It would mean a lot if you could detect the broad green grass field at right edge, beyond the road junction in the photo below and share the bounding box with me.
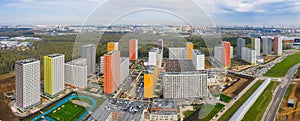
[264,52,300,77]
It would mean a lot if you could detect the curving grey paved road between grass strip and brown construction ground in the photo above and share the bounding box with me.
[264,64,300,121]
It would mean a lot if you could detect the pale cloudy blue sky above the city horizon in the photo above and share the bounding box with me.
[0,0,300,26]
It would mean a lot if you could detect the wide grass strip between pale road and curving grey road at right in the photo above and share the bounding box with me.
[242,81,280,121]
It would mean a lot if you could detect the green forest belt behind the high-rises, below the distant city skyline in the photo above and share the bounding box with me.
[0,33,248,74]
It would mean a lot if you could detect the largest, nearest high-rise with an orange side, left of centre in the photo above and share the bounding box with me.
[103,51,120,94]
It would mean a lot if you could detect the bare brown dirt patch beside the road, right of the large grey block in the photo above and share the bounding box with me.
[223,75,252,98]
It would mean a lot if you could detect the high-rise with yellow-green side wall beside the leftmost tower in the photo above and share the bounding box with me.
[44,54,65,97]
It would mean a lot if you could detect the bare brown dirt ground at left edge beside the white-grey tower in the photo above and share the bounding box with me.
[0,76,19,121]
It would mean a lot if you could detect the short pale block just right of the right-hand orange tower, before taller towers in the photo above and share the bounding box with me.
[241,47,256,64]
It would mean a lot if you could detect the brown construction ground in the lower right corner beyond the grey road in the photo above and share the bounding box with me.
[277,81,300,121]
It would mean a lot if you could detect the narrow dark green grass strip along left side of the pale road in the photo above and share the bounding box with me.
[219,80,263,121]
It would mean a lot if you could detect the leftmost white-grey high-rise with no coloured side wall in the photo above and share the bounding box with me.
[15,59,41,110]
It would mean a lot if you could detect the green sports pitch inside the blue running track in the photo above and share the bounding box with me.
[47,102,86,121]
